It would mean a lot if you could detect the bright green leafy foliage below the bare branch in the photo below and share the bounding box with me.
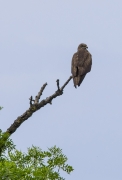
[0,133,73,180]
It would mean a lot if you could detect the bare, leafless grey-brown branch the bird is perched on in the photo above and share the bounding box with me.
[6,76,72,135]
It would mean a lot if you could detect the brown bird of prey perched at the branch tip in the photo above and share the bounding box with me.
[71,43,92,88]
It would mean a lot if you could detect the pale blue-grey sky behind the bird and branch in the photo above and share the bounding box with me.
[0,0,122,180]
